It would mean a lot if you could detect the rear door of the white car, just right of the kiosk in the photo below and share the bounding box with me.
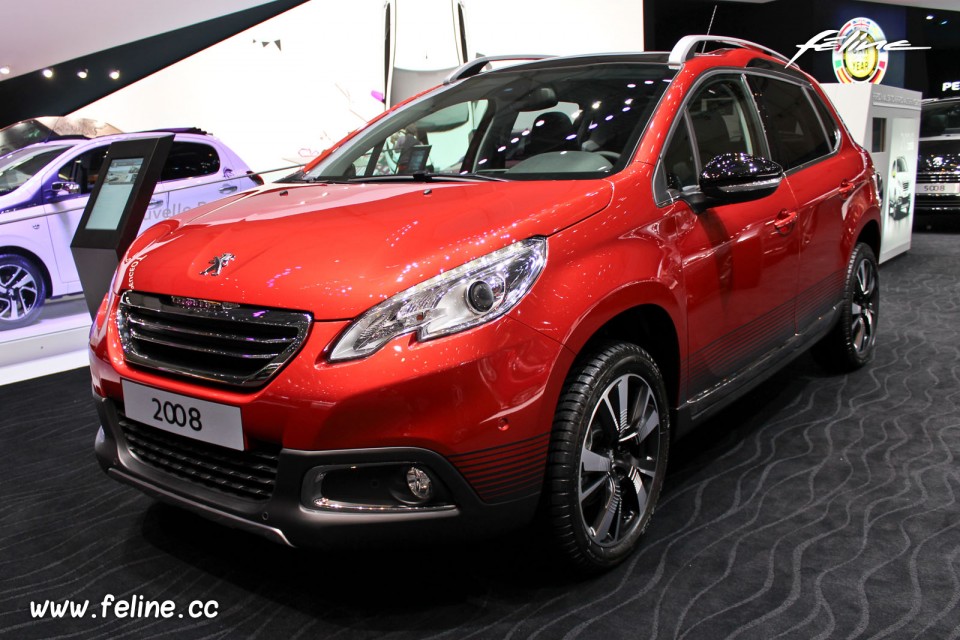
[157,140,240,220]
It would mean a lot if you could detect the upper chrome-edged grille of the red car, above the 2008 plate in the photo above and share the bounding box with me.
[117,291,311,387]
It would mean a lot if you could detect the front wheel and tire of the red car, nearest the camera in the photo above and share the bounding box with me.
[546,343,670,573]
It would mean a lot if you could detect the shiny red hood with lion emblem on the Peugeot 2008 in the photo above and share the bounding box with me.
[124,180,613,320]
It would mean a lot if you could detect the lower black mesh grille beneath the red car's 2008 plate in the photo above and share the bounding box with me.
[120,414,280,500]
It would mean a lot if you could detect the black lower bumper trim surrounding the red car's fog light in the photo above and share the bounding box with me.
[95,397,538,548]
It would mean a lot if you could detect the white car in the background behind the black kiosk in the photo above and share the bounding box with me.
[0,129,263,330]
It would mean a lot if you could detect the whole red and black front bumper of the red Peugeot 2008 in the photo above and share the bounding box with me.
[90,284,573,546]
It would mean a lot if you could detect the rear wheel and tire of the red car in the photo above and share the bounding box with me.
[813,242,880,372]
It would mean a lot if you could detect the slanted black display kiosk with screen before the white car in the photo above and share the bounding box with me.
[70,135,173,316]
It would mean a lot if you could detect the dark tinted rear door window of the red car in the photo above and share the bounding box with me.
[748,75,833,171]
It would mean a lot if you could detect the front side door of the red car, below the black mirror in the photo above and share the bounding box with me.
[661,74,799,401]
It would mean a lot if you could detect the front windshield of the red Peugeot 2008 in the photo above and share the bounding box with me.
[300,62,673,182]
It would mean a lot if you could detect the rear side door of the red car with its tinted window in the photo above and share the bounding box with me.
[747,74,868,333]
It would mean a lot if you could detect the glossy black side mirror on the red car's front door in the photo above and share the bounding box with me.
[690,153,783,212]
